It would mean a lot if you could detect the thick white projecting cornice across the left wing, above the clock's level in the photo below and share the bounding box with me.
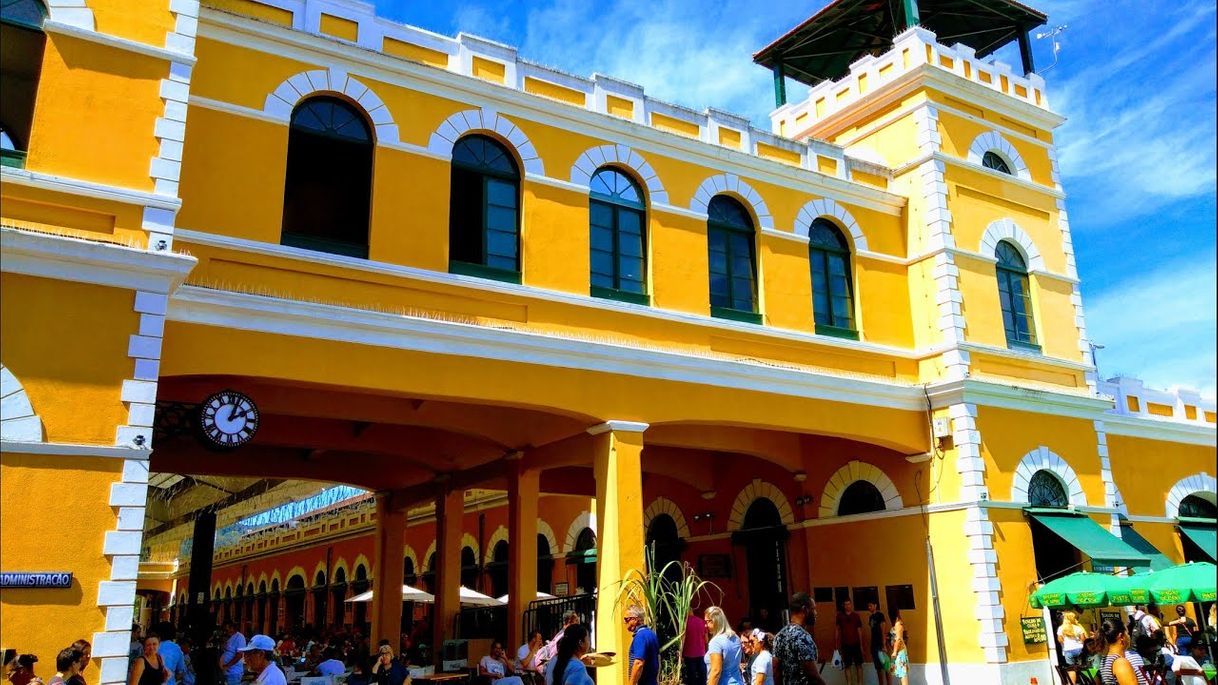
[0,227,197,293]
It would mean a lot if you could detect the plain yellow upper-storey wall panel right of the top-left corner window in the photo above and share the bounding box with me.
[26,34,169,190]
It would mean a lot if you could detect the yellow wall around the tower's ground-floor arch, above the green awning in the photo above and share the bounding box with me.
[977,406,1106,507]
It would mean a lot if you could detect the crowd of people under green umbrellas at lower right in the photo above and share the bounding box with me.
[1054,605,1218,685]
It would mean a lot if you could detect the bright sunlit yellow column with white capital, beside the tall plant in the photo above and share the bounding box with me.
[588,421,647,685]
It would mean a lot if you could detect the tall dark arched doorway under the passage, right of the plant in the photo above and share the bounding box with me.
[732,497,788,620]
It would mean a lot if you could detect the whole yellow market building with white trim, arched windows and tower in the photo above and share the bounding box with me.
[0,0,1218,684]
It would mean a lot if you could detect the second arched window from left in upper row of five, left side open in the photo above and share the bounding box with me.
[448,135,520,283]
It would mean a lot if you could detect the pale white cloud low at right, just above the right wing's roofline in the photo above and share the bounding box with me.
[1085,255,1218,396]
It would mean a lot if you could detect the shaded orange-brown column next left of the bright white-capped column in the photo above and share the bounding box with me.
[507,460,540,653]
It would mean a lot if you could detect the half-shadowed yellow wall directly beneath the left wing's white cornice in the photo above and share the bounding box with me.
[0,273,139,443]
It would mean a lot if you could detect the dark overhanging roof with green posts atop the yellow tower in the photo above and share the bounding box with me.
[753,0,1047,85]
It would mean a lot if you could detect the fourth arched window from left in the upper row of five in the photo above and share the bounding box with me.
[706,195,761,323]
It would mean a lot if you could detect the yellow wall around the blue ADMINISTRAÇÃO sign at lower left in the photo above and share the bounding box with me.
[0,455,123,678]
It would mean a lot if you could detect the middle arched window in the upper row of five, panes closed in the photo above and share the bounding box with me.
[588,168,650,305]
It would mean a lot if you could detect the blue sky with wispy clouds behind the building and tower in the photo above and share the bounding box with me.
[376,0,1218,396]
